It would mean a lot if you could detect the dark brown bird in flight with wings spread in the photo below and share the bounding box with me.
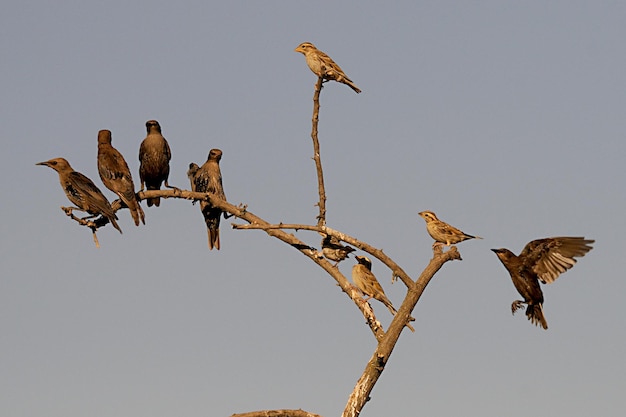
[491,236,595,330]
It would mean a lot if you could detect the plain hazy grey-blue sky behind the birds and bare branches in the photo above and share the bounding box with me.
[0,1,626,417]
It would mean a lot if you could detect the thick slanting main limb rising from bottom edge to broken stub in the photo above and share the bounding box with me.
[342,246,461,417]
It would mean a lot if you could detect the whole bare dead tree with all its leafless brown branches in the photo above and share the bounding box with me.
[37,78,461,417]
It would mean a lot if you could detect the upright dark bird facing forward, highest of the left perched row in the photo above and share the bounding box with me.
[139,120,172,207]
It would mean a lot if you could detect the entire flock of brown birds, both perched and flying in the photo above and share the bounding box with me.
[37,42,594,330]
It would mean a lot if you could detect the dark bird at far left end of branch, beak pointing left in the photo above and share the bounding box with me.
[36,158,122,233]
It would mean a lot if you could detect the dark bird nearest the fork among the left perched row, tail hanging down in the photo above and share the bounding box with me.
[194,149,226,250]
